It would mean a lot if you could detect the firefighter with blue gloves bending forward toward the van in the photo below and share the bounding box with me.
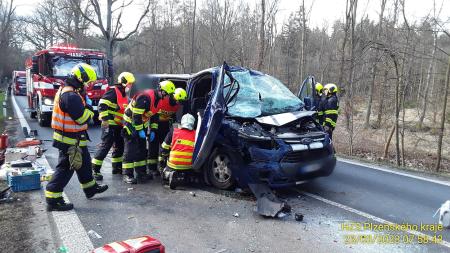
[122,81,175,184]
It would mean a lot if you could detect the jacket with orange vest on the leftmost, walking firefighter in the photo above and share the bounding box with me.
[51,86,94,148]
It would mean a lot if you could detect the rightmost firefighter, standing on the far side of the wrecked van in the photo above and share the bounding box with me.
[323,83,339,139]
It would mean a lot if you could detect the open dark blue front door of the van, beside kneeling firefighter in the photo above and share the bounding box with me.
[192,63,228,170]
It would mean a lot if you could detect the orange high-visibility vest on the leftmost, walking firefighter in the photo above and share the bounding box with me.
[51,86,88,133]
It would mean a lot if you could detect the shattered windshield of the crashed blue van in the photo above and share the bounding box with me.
[224,70,303,118]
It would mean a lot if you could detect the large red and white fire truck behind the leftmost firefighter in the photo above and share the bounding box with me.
[25,46,112,126]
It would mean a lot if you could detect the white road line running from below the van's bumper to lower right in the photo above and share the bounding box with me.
[298,191,450,248]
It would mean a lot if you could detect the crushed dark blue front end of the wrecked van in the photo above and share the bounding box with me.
[217,111,336,188]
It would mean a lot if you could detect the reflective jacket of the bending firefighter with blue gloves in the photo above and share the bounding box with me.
[123,90,159,135]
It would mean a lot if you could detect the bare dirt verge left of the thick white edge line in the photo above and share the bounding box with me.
[0,96,55,252]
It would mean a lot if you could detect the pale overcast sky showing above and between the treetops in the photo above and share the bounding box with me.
[14,0,450,35]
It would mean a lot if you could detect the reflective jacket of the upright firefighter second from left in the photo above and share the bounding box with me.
[98,85,128,126]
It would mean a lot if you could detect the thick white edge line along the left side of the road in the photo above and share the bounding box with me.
[11,96,94,253]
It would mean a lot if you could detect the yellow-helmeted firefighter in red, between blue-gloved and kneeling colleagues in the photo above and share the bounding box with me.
[147,88,187,175]
